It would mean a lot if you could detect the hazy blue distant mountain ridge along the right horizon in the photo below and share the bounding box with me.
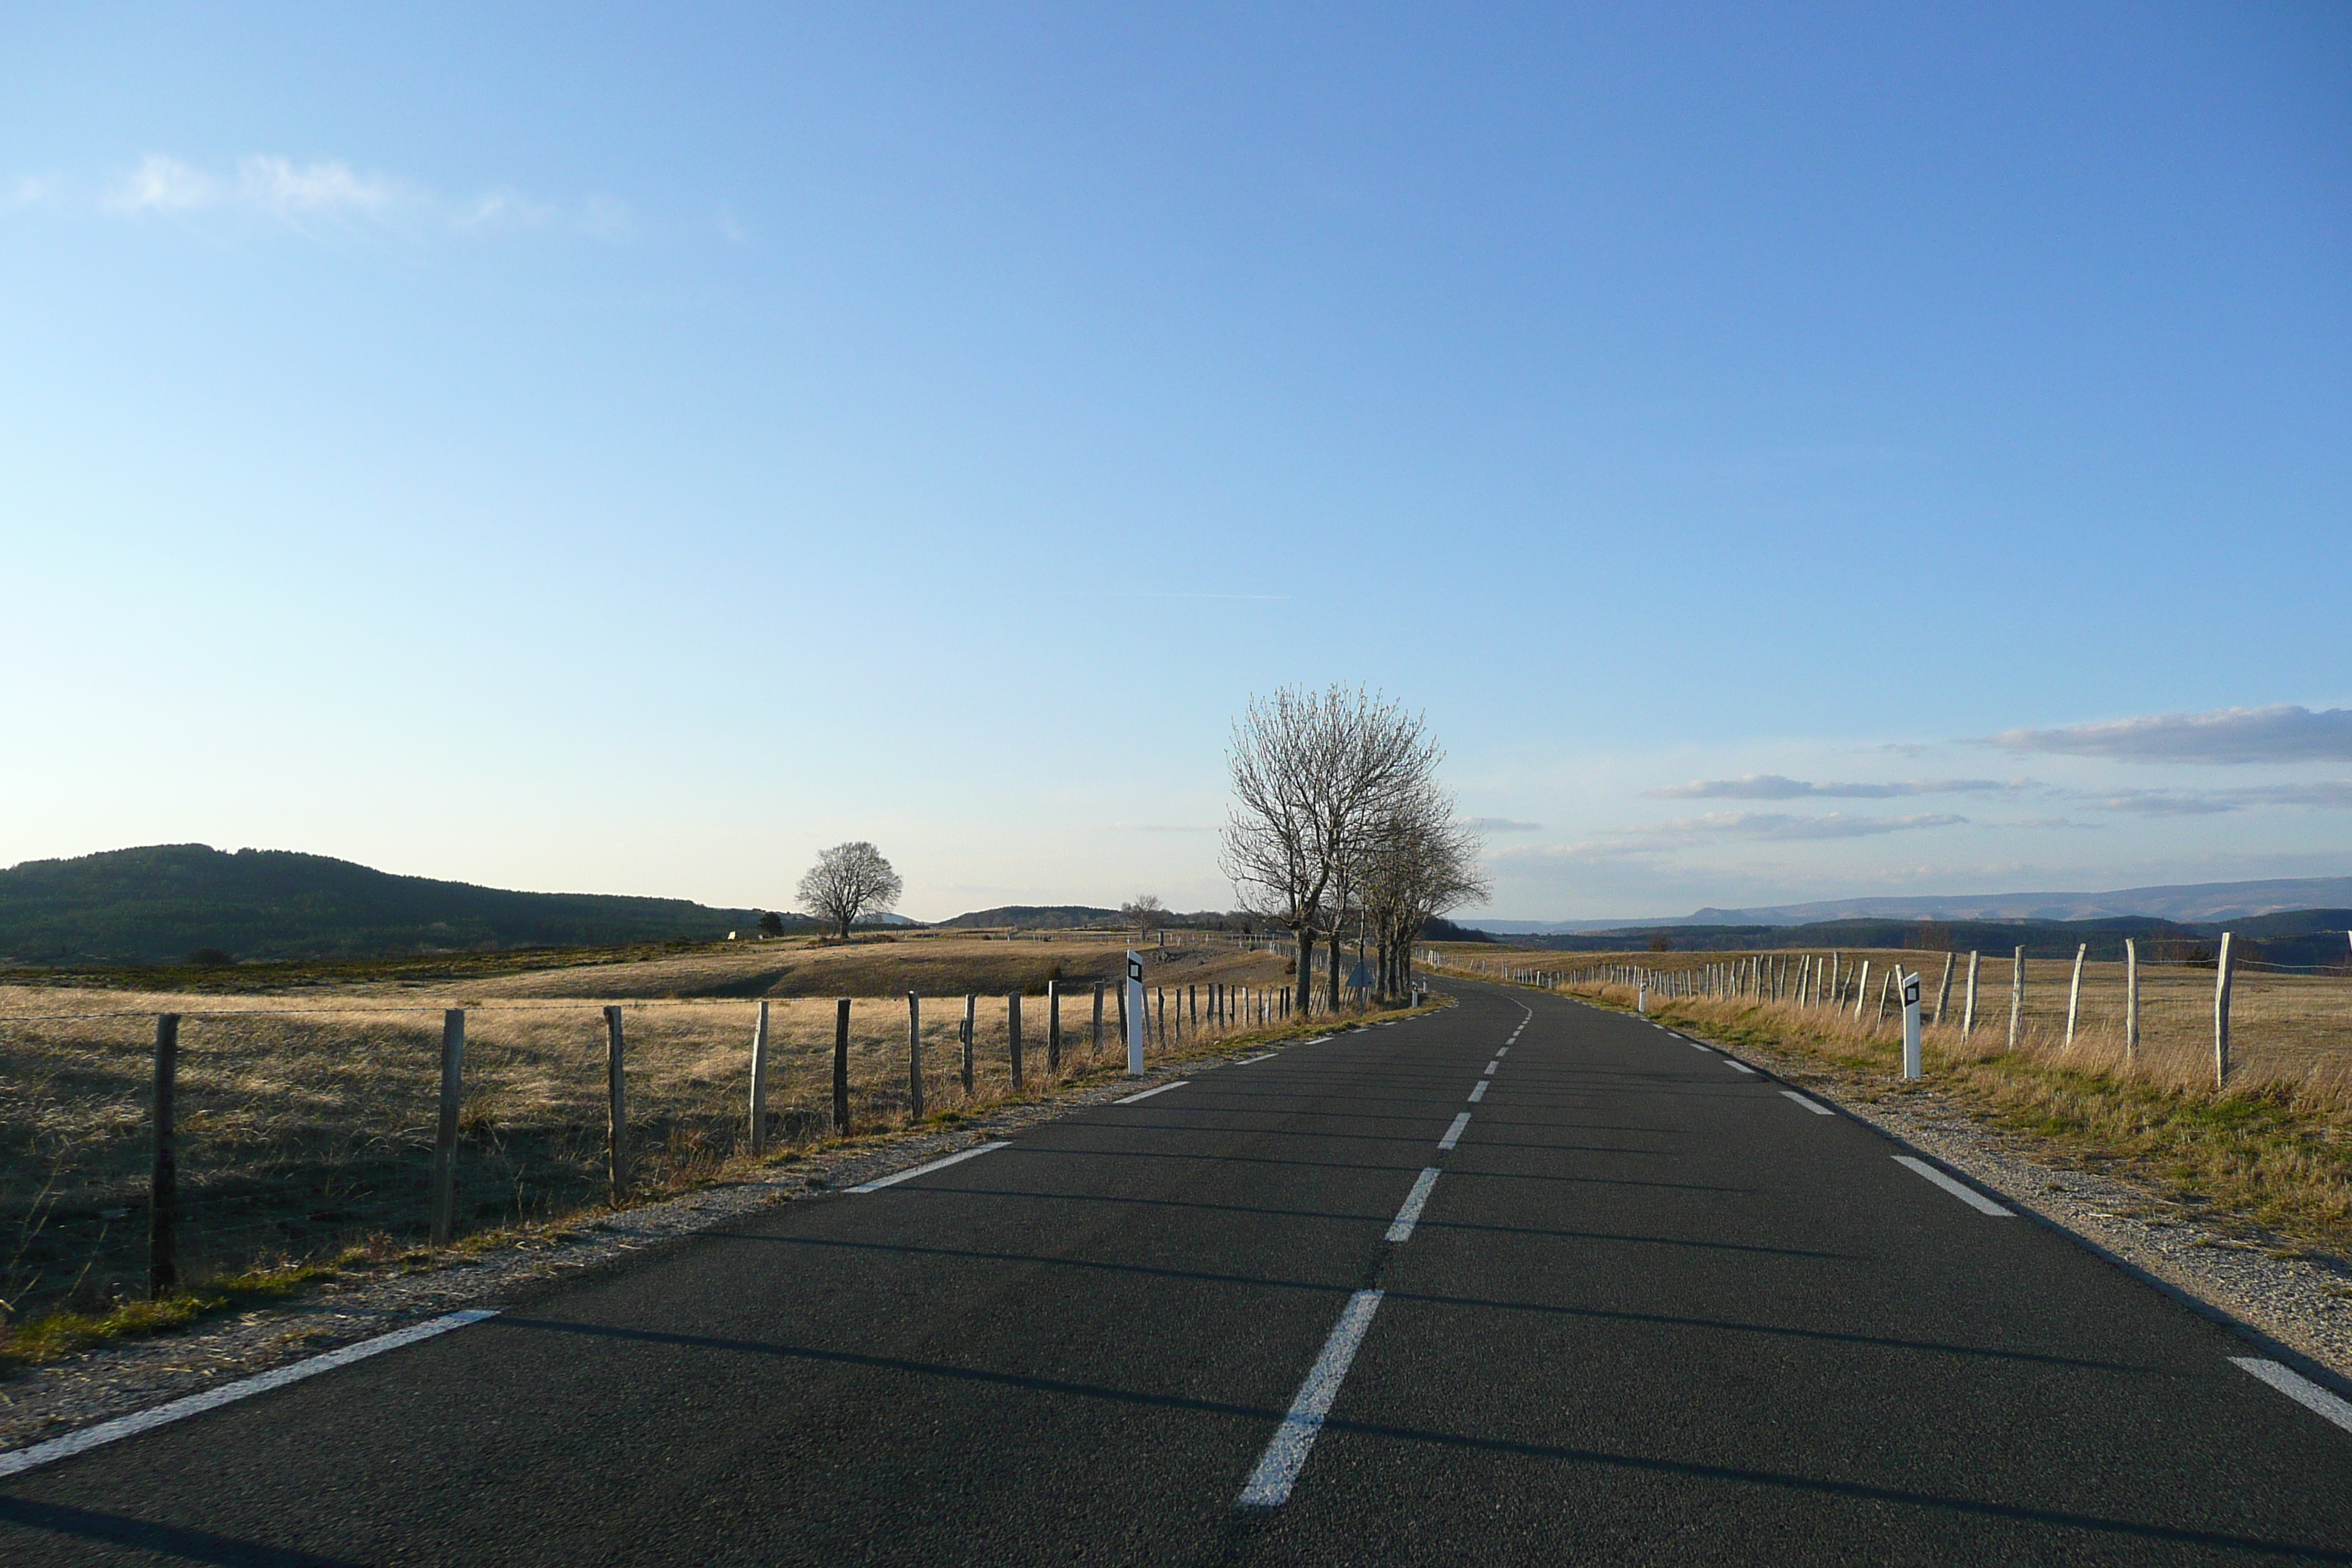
[1463,877,2352,935]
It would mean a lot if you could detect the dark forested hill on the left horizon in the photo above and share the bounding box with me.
[0,844,760,964]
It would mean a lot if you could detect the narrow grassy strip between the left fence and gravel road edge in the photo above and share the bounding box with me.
[0,1004,1441,1375]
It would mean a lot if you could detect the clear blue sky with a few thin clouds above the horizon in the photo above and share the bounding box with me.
[0,4,2352,917]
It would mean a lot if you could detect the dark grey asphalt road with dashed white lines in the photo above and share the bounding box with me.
[0,985,2352,1566]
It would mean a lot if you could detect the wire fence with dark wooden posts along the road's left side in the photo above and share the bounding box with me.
[0,985,1289,1319]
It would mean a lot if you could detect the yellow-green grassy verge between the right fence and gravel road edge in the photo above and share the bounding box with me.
[1542,987,2352,1258]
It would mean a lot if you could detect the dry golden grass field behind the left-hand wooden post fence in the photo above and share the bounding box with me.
[0,935,1286,1316]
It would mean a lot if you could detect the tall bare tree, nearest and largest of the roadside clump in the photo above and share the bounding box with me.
[1218,687,1441,1009]
